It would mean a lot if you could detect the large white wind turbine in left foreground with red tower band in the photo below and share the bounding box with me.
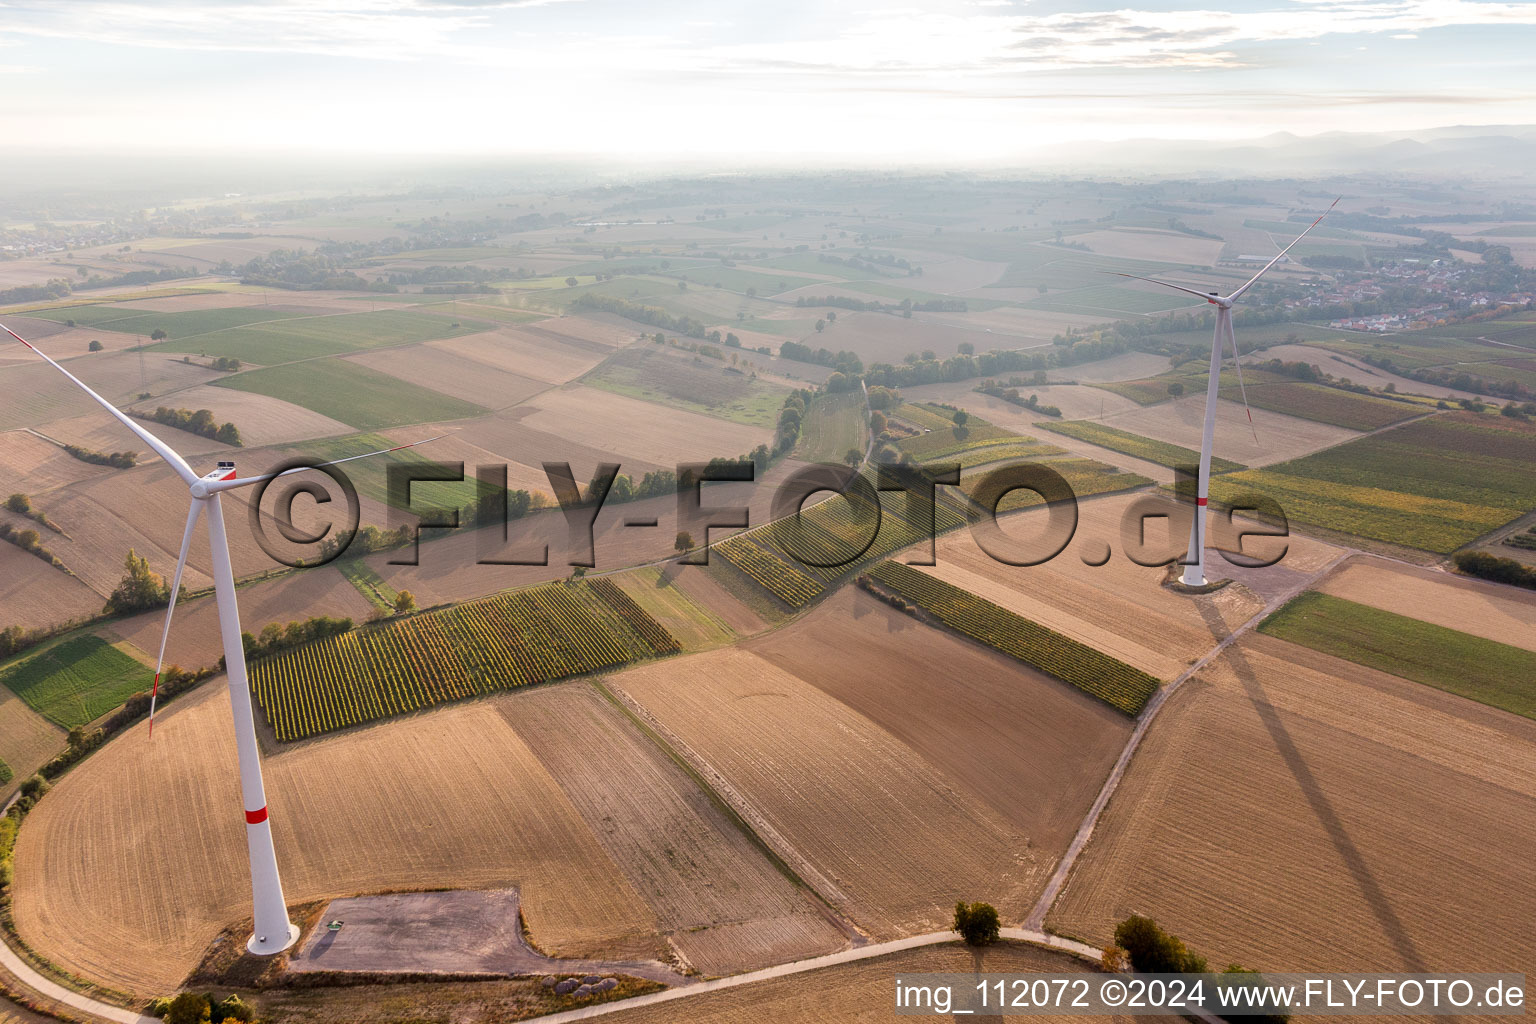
[0,324,436,956]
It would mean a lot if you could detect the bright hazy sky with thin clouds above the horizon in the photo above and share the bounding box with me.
[0,0,1536,160]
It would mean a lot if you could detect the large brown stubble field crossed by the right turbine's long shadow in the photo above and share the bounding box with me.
[1048,636,1536,970]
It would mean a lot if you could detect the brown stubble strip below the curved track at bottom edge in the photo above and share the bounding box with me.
[605,941,1137,1024]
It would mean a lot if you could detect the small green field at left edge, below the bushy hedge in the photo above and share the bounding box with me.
[0,634,154,729]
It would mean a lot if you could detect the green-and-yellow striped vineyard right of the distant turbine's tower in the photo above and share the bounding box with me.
[1212,413,1536,554]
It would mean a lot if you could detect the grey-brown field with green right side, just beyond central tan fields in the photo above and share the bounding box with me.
[582,345,788,428]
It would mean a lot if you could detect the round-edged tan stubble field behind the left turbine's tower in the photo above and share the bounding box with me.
[12,680,660,996]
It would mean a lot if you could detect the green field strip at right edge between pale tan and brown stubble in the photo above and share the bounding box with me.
[1260,591,1536,718]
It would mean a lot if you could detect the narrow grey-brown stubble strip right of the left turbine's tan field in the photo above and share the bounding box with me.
[501,683,846,975]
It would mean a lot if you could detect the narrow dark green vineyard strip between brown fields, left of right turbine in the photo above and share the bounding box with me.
[869,562,1160,715]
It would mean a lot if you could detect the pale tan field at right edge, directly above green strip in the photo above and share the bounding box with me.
[1318,556,1536,651]
